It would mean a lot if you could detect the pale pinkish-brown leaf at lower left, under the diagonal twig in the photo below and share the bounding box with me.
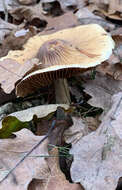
[0,129,49,190]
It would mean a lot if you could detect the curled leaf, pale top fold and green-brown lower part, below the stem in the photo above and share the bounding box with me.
[0,104,69,139]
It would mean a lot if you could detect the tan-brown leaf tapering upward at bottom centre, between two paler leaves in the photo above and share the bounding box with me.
[28,149,83,190]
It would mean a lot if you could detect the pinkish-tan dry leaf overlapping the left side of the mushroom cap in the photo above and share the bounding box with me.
[0,58,38,105]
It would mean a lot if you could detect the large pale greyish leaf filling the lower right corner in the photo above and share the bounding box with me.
[70,92,122,190]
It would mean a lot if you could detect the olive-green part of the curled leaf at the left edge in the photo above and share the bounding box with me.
[0,116,30,139]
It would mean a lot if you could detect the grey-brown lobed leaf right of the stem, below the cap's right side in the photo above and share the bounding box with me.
[83,72,122,113]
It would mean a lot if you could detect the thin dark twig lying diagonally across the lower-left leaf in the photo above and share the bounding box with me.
[0,120,56,183]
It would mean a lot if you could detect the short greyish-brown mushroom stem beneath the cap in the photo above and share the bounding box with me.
[54,79,71,105]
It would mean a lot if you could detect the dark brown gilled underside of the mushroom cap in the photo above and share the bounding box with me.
[16,68,88,97]
